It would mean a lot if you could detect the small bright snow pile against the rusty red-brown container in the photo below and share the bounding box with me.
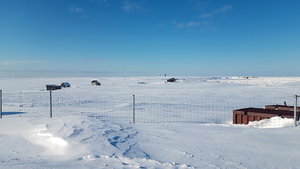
[249,116,294,128]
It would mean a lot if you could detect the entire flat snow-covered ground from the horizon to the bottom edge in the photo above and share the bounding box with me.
[0,77,300,169]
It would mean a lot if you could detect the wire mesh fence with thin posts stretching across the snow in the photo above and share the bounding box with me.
[0,90,297,124]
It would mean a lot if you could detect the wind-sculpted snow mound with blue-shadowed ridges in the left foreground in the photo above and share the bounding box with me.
[0,116,194,169]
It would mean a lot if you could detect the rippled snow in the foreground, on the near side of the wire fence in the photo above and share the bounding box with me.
[0,116,300,169]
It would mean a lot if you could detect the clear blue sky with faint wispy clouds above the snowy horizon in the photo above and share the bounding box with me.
[0,0,300,76]
